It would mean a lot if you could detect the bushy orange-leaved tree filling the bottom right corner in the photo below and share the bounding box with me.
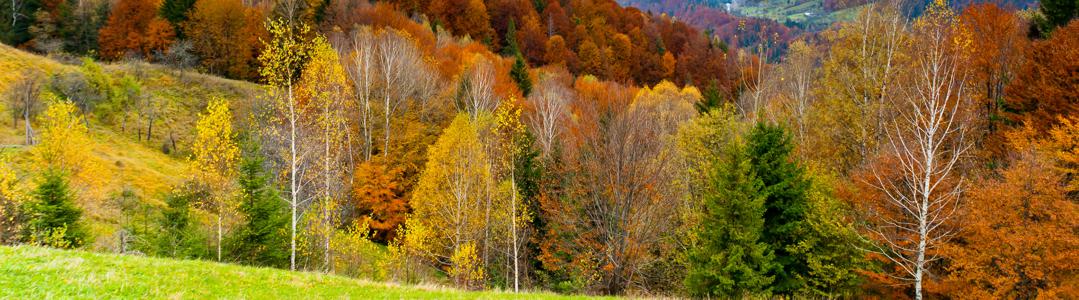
[937,125,1079,299]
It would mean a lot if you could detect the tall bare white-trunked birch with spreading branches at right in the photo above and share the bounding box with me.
[869,4,971,299]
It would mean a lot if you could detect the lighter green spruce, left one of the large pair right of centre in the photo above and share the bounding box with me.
[684,142,774,298]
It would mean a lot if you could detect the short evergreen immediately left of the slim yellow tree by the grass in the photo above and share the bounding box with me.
[148,186,209,259]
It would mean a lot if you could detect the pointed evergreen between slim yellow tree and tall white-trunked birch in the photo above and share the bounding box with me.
[226,144,289,268]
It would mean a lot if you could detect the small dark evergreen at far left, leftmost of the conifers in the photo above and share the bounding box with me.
[25,171,88,248]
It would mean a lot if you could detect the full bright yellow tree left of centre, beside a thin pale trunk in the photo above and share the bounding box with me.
[411,113,509,287]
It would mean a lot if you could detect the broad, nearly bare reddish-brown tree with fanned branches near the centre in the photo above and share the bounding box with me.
[551,83,693,295]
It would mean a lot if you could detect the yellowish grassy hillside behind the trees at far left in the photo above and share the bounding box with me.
[0,44,262,250]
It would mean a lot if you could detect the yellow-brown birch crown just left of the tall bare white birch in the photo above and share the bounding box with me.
[815,2,909,172]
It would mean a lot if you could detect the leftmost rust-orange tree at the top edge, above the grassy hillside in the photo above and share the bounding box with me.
[98,0,175,59]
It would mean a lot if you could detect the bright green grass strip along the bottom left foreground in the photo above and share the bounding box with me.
[0,246,599,299]
